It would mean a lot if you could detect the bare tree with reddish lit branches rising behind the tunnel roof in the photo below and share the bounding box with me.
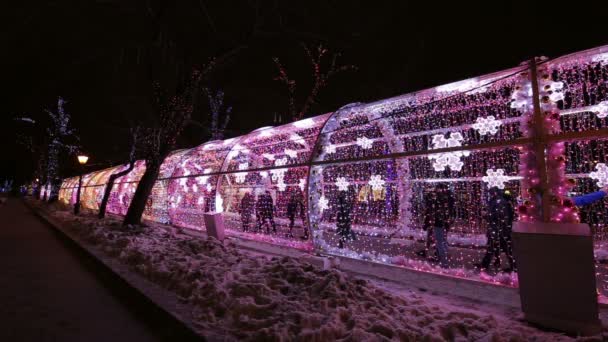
[272,44,356,121]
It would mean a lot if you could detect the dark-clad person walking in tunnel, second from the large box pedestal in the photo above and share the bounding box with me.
[417,183,456,268]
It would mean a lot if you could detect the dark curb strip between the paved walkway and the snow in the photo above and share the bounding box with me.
[23,201,206,341]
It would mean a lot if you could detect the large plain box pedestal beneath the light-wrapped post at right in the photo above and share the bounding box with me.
[513,222,601,335]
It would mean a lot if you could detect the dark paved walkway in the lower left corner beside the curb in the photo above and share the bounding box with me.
[0,199,163,342]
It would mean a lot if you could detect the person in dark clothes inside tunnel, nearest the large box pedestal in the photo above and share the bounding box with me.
[479,187,516,272]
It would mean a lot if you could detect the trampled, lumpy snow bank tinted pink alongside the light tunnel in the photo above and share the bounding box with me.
[46,204,601,341]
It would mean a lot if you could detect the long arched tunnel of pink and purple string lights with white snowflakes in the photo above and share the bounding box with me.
[55,46,608,293]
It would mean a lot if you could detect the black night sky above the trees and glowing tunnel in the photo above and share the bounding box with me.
[0,0,608,182]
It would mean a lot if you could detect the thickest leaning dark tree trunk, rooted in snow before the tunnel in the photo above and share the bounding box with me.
[123,68,208,225]
